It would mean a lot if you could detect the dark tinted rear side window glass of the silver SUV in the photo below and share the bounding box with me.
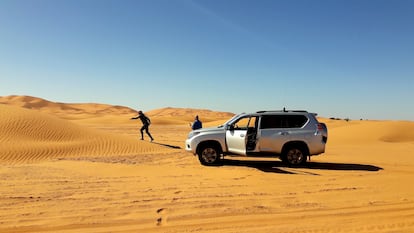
[260,115,308,129]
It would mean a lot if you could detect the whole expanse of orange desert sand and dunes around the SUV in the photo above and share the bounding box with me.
[0,96,414,233]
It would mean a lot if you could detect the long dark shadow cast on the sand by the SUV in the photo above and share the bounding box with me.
[221,159,383,175]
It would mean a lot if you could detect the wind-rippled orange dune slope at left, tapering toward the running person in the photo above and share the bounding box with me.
[0,104,171,163]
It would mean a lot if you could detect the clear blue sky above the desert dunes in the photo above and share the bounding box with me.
[0,0,414,120]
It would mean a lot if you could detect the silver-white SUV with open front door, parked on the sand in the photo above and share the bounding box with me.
[185,109,328,165]
